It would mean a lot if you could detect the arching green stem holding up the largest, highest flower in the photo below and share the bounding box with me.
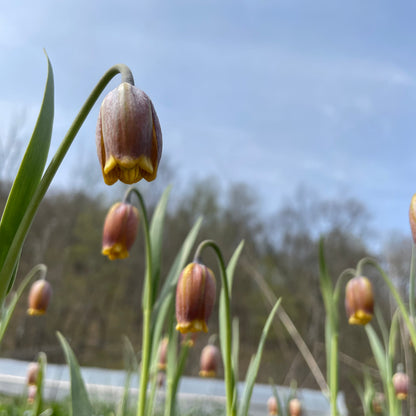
[0,64,133,303]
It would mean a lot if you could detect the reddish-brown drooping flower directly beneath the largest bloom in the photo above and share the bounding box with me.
[102,202,139,260]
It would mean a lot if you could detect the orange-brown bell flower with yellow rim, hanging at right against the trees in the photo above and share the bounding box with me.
[345,276,374,325]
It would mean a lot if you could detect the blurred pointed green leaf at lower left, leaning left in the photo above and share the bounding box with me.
[57,332,94,416]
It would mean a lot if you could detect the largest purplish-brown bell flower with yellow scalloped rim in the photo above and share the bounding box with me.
[96,82,162,185]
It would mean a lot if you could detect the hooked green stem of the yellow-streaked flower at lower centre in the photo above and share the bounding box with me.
[195,240,237,416]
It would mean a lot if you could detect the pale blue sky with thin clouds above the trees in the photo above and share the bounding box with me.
[0,0,416,242]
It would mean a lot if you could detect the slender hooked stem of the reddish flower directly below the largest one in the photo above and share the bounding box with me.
[124,188,153,416]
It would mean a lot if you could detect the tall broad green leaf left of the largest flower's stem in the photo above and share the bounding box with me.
[0,53,54,303]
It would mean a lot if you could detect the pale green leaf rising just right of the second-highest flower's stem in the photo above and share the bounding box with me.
[150,186,172,303]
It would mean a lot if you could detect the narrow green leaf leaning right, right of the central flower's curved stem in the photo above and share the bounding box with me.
[238,298,281,416]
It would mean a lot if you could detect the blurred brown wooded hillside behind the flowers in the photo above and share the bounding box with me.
[0,124,411,416]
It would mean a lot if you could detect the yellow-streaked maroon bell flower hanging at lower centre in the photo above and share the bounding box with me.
[176,262,216,334]
